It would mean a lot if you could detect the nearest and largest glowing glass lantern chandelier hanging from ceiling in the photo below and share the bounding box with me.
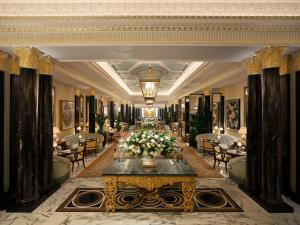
[139,65,160,107]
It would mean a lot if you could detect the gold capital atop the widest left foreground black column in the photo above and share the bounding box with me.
[14,47,41,70]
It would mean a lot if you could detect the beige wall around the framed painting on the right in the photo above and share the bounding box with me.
[224,81,247,136]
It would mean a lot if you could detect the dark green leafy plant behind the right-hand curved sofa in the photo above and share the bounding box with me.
[189,108,206,147]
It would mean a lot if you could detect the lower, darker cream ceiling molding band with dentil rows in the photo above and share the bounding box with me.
[0,16,300,46]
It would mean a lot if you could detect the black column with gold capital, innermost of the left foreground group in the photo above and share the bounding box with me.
[38,56,54,193]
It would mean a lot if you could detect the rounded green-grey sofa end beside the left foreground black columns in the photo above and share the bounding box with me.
[52,156,71,185]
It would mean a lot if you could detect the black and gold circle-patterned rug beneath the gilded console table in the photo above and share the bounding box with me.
[56,188,243,212]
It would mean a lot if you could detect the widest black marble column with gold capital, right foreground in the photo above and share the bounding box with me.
[260,47,284,205]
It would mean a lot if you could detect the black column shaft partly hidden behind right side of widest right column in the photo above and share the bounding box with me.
[279,74,291,196]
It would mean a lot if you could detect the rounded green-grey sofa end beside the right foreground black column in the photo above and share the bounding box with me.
[228,156,246,184]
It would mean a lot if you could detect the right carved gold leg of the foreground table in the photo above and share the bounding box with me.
[182,179,196,212]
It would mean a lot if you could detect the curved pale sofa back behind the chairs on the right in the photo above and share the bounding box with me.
[196,133,241,149]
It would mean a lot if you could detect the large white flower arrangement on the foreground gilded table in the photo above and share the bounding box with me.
[124,130,177,159]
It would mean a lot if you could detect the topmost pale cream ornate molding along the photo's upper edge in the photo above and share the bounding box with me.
[0,0,300,17]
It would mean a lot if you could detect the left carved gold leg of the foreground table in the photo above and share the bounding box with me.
[104,177,118,212]
